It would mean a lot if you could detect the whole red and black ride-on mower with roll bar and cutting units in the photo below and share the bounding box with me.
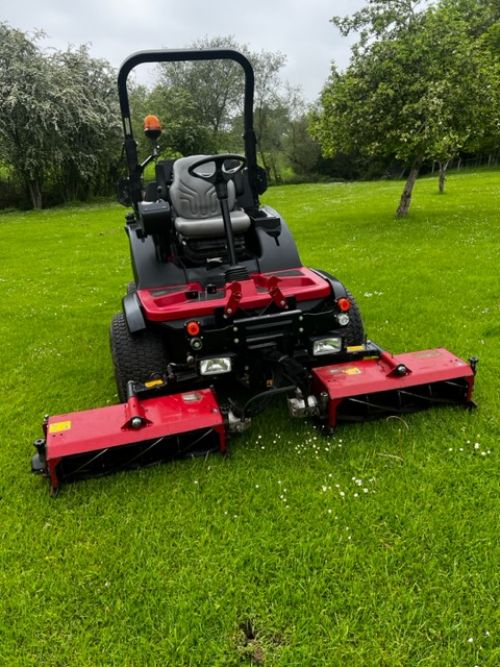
[32,49,475,493]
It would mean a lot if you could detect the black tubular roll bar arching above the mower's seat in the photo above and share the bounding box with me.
[118,49,258,205]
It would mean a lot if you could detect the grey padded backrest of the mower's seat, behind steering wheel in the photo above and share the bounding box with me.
[170,155,236,220]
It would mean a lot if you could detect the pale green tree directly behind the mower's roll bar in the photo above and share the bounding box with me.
[156,37,286,175]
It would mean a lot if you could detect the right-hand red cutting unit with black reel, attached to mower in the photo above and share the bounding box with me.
[312,348,474,427]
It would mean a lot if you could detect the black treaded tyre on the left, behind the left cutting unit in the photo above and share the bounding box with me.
[110,313,168,401]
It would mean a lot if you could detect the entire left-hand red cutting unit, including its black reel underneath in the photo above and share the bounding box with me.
[38,389,226,492]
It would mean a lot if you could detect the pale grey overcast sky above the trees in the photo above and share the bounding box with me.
[0,0,365,101]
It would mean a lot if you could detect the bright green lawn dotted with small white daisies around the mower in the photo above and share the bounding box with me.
[0,172,500,667]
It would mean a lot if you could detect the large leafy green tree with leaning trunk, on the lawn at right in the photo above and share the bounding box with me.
[314,0,498,217]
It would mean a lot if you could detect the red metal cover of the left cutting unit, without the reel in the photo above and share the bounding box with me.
[44,389,226,491]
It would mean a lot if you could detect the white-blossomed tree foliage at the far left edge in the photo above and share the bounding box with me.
[0,23,119,208]
